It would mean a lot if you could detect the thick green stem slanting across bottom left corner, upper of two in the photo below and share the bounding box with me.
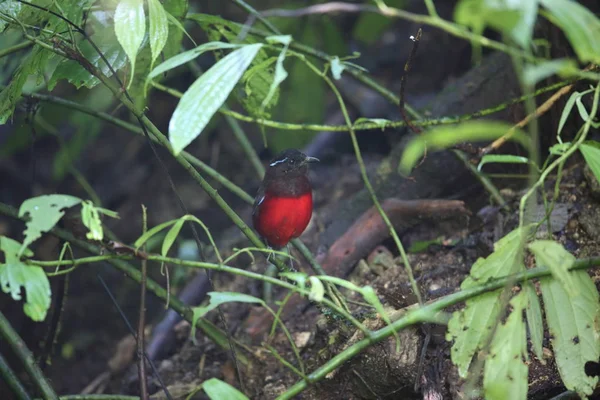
[0,312,58,400]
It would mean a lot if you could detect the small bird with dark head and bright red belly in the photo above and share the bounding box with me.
[252,149,319,249]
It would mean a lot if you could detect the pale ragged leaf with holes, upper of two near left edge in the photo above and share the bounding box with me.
[19,194,81,254]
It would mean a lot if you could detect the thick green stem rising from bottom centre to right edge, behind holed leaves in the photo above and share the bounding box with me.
[277,257,600,400]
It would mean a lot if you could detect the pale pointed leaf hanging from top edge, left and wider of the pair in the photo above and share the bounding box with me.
[114,0,146,84]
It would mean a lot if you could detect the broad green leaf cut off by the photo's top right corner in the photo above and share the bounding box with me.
[540,0,600,63]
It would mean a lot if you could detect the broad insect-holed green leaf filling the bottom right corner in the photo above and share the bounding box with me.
[540,271,600,397]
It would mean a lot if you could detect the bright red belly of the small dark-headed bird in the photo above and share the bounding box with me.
[254,191,312,247]
